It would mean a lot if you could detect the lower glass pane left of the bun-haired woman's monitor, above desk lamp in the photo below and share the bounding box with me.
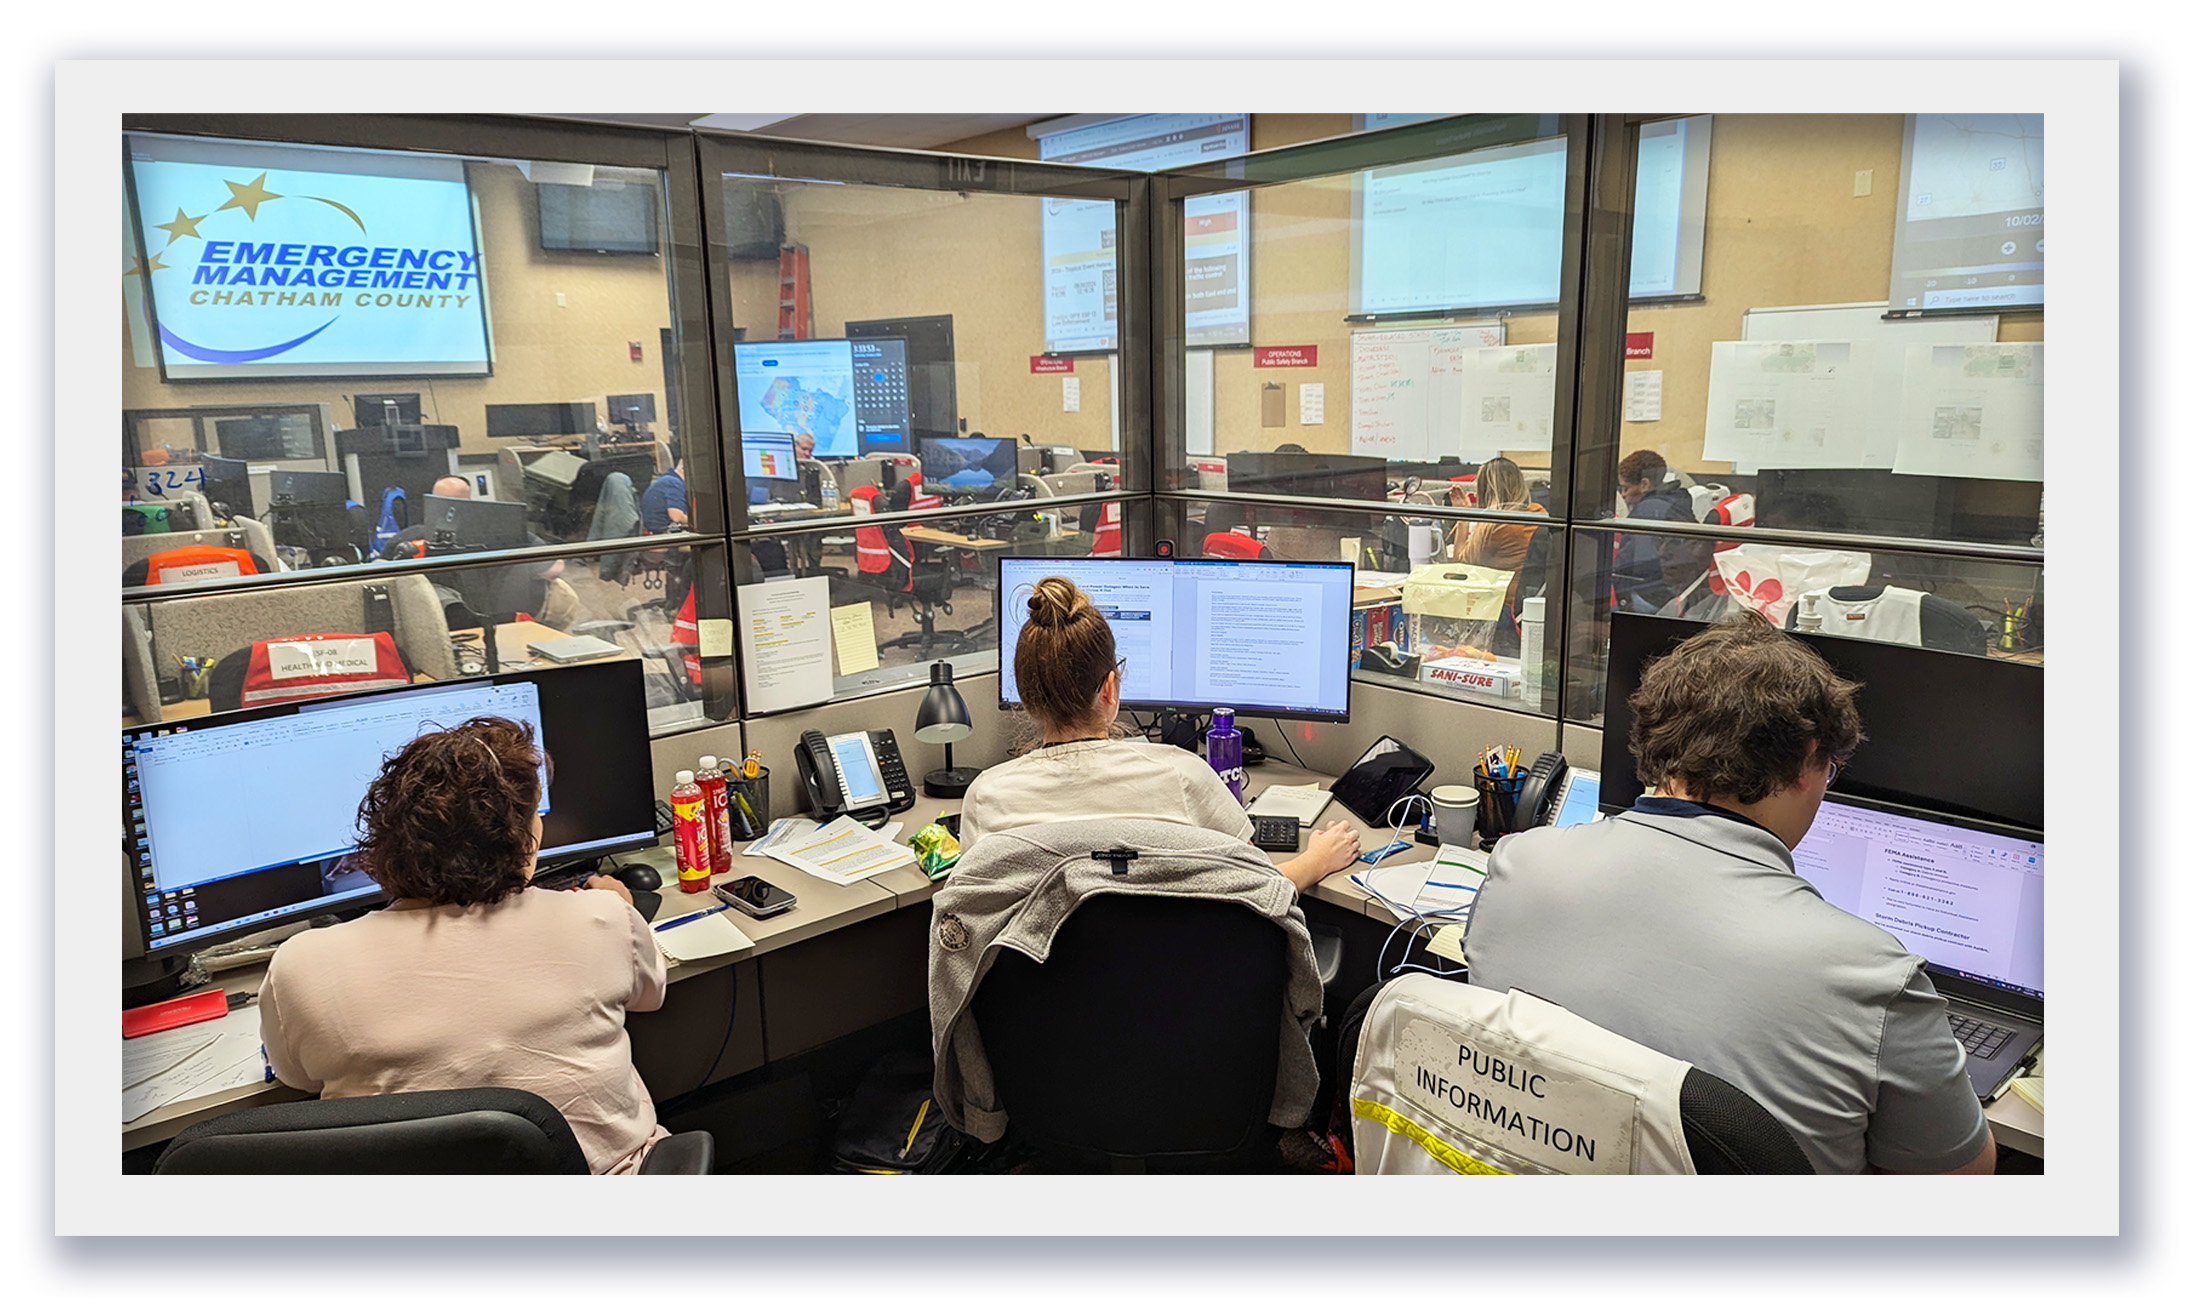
[735,498,1148,708]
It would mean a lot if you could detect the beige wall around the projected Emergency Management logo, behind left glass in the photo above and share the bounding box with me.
[122,164,673,452]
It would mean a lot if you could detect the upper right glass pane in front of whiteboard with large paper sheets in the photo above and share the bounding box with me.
[1592,114,2043,546]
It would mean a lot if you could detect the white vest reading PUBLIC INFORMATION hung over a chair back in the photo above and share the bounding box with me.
[1352,975,1693,1176]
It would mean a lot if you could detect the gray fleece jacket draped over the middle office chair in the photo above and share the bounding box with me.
[927,817,1321,1141]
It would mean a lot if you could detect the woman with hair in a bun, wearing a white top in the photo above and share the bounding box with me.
[958,577,1360,892]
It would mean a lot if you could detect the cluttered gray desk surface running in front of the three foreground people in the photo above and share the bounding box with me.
[122,760,2043,1158]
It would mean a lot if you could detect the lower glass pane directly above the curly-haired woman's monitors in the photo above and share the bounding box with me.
[122,537,733,732]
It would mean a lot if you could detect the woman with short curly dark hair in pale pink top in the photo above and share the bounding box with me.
[260,717,667,1173]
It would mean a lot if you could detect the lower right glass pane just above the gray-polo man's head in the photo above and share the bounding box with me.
[1564,529,2043,721]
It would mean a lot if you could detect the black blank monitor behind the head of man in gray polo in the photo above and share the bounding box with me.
[1603,612,2043,828]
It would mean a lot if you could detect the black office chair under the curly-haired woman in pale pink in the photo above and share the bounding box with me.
[153,1086,713,1176]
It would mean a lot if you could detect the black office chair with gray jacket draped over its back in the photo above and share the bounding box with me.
[973,894,1288,1171]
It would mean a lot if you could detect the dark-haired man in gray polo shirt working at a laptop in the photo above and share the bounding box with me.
[1465,614,1997,1173]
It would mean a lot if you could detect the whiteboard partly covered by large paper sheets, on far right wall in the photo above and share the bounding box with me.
[1732,302,1997,474]
